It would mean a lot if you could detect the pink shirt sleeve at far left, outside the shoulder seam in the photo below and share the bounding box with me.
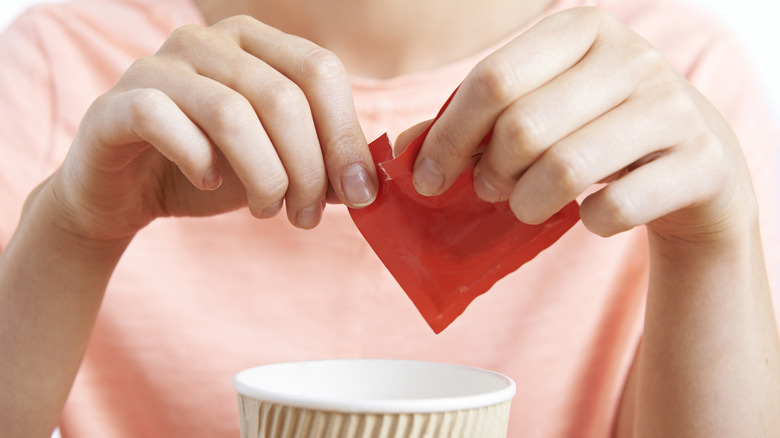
[0,10,53,249]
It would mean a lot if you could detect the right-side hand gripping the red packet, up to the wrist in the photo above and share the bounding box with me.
[414,8,755,246]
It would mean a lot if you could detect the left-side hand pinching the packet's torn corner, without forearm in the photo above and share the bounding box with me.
[49,17,377,240]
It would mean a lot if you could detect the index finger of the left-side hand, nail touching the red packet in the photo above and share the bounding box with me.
[216,19,378,207]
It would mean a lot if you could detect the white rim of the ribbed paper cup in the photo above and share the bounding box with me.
[233,359,516,414]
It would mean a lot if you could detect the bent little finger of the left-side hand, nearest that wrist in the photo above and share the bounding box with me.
[85,88,222,190]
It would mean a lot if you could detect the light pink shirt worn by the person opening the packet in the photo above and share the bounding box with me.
[0,0,780,438]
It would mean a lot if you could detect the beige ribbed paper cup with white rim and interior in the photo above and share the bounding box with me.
[233,359,515,438]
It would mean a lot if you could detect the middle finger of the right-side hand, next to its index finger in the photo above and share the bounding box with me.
[474,33,641,202]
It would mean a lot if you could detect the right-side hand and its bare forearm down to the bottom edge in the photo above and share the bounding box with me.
[406,8,780,437]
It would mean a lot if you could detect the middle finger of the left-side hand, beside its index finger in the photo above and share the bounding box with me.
[158,23,328,228]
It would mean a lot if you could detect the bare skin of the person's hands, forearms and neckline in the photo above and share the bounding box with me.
[0,0,780,437]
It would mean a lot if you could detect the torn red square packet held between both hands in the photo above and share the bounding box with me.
[350,92,579,333]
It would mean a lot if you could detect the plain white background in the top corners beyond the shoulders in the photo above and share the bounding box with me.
[0,0,780,115]
